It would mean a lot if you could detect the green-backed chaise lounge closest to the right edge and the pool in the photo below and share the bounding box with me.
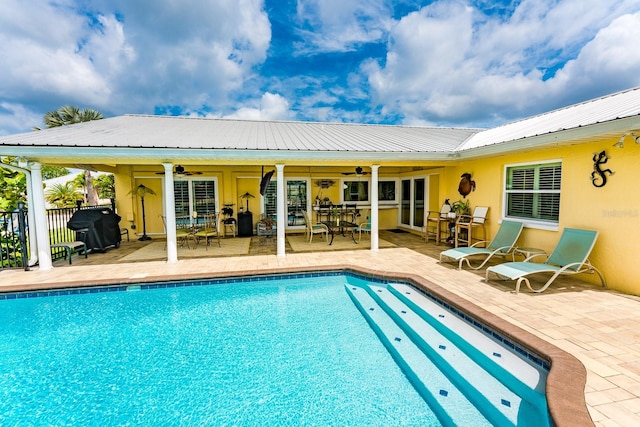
[485,228,607,293]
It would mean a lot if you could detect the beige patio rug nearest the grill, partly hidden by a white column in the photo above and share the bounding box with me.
[120,237,251,262]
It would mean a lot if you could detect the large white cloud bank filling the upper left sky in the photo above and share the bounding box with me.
[0,0,271,125]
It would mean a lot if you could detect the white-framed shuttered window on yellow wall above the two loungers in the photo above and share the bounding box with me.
[505,162,562,224]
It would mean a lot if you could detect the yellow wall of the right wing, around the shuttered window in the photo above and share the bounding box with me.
[442,140,640,295]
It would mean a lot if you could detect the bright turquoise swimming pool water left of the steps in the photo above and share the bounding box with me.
[0,273,552,426]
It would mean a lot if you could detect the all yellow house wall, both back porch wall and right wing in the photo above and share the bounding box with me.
[115,149,640,295]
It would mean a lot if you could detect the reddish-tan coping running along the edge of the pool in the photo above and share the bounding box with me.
[1,264,595,427]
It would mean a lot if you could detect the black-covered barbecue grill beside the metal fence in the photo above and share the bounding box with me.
[67,208,122,251]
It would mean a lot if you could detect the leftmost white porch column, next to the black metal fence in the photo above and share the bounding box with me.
[27,163,53,270]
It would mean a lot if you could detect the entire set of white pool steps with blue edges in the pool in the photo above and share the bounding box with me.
[345,284,548,426]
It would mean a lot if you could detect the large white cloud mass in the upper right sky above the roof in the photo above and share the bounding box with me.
[362,0,640,125]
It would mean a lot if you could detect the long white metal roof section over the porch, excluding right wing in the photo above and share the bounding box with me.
[0,115,479,153]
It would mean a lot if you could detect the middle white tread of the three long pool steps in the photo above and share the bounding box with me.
[369,285,530,425]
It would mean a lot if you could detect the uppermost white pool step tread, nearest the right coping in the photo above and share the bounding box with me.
[387,283,547,398]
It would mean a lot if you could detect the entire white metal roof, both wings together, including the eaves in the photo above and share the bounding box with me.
[0,87,640,161]
